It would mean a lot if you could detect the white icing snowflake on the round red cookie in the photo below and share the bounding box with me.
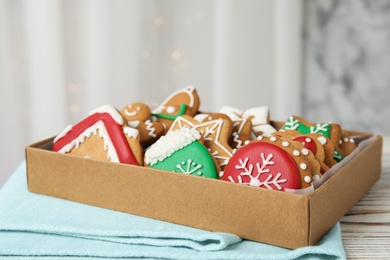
[232,153,287,190]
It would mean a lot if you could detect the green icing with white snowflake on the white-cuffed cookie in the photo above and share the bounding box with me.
[150,141,218,179]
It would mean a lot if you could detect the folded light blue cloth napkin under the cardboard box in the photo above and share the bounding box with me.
[0,162,345,259]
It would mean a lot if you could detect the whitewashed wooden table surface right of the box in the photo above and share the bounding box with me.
[341,136,390,259]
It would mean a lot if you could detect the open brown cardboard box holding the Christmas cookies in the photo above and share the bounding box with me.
[26,132,382,248]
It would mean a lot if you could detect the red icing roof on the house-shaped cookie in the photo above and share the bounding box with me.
[53,113,139,165]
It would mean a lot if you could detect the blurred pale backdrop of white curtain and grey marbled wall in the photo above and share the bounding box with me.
[0,0,390,186]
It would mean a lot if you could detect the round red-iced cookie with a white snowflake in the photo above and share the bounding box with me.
[222,142,301,191]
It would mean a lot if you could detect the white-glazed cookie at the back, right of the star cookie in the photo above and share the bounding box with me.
[220,106,276,139]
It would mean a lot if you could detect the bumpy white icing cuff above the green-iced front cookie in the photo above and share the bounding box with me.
[145,127,201,166]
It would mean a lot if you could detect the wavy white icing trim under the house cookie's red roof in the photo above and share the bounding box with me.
[58,121,119,162]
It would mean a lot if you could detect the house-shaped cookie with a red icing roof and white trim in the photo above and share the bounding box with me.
[53,105,143,165]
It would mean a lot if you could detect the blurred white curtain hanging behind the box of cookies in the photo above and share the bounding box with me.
[0,0,301,186]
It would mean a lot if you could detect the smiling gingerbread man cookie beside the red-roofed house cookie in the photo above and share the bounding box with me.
[120,103,165,147]
